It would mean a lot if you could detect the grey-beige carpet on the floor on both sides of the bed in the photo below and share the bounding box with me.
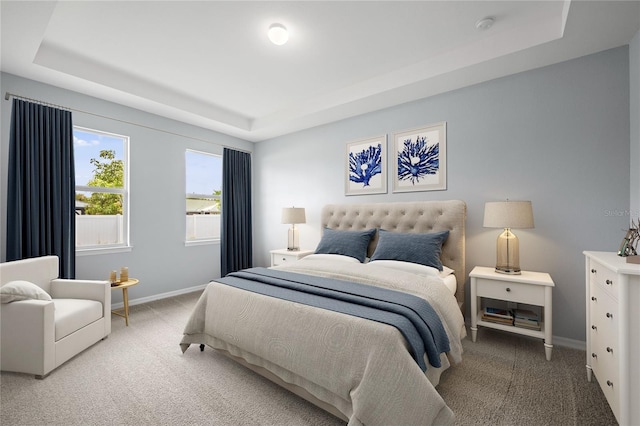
[0,293,616,425]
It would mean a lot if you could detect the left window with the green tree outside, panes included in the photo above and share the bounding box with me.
[73,126,129,251]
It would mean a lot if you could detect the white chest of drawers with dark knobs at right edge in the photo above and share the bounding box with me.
[584,251,640,425]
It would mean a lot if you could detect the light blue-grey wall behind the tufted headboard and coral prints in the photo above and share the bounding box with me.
[254,46,630,341]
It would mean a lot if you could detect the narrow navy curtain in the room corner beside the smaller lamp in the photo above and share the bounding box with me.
[220,148,253,277]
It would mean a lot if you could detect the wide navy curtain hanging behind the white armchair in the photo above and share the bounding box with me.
[6,99,76,278]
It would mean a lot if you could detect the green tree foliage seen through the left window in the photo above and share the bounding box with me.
[83,150,124,215]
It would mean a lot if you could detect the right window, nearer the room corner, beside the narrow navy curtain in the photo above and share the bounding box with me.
[185,150,222,243]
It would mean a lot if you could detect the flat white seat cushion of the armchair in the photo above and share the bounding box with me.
[53,299,102,342]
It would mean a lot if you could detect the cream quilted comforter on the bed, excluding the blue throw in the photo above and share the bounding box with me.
[181,260,466,425]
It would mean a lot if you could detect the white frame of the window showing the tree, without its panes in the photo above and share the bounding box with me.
[73,125,132,256]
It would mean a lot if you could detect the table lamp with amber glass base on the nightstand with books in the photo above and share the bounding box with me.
[483,200,533,275]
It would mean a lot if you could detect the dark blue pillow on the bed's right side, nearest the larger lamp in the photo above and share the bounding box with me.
[371,229,449,271]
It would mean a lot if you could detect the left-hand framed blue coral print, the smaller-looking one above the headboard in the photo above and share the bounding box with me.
[345,135,387,195]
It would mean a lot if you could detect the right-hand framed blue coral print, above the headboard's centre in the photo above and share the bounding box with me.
[393,122,447,192]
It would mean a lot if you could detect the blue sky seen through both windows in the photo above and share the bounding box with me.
[73,128,222,195]
